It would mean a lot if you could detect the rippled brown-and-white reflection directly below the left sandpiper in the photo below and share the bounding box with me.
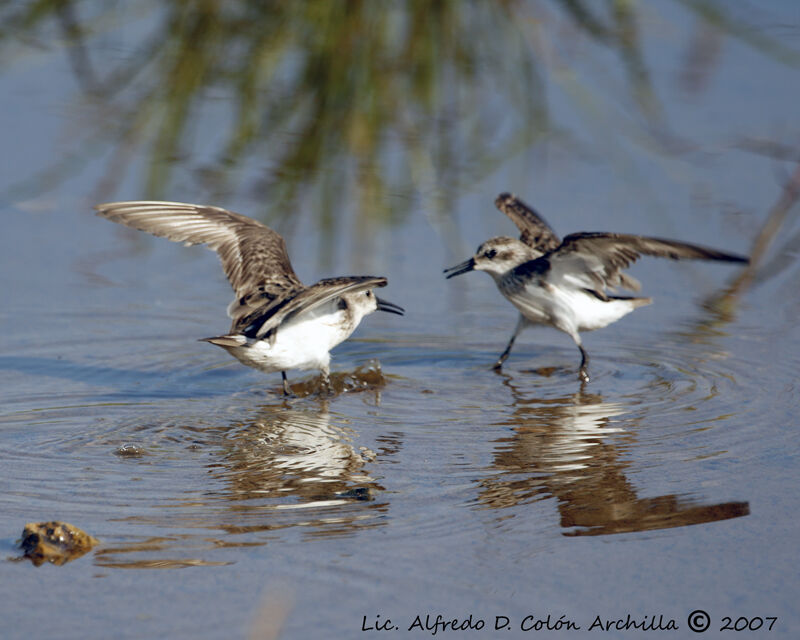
[212,400,387,536]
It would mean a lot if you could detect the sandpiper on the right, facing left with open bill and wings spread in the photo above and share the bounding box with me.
[445,193,748,381]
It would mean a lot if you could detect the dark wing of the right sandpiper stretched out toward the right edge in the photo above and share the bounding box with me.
[540,233,749,291]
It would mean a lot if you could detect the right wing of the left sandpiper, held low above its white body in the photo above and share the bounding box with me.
[234,276,387,338]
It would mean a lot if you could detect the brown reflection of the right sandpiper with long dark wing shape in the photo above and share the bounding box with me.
[478,374,750,536]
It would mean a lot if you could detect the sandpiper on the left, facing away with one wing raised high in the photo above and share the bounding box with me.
[95,200,404,395]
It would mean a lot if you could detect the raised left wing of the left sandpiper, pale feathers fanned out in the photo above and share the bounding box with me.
[95,200,304,322]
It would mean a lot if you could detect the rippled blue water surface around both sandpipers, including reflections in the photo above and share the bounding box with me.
[0,2,800,638]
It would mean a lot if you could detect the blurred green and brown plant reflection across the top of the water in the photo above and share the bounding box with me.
[0,0,800,230]
